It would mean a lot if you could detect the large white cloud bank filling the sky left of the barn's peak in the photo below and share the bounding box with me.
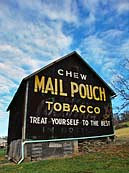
[0,0,74,135]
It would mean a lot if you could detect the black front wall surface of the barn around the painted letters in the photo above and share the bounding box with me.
[26,55,113,140]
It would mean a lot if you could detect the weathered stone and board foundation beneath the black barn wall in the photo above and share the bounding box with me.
[8,137,113,163]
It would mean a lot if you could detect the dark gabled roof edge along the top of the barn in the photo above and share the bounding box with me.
[7,51,116,111]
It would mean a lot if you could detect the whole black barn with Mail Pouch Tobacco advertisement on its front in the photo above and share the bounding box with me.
[7,51,115,163]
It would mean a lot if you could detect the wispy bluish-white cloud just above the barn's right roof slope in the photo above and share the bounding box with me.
[79,30,121,81]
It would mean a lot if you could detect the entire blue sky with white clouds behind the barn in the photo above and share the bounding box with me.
[0,0,129,136]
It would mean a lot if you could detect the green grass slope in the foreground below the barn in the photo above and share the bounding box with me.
[0,139,129,173]
